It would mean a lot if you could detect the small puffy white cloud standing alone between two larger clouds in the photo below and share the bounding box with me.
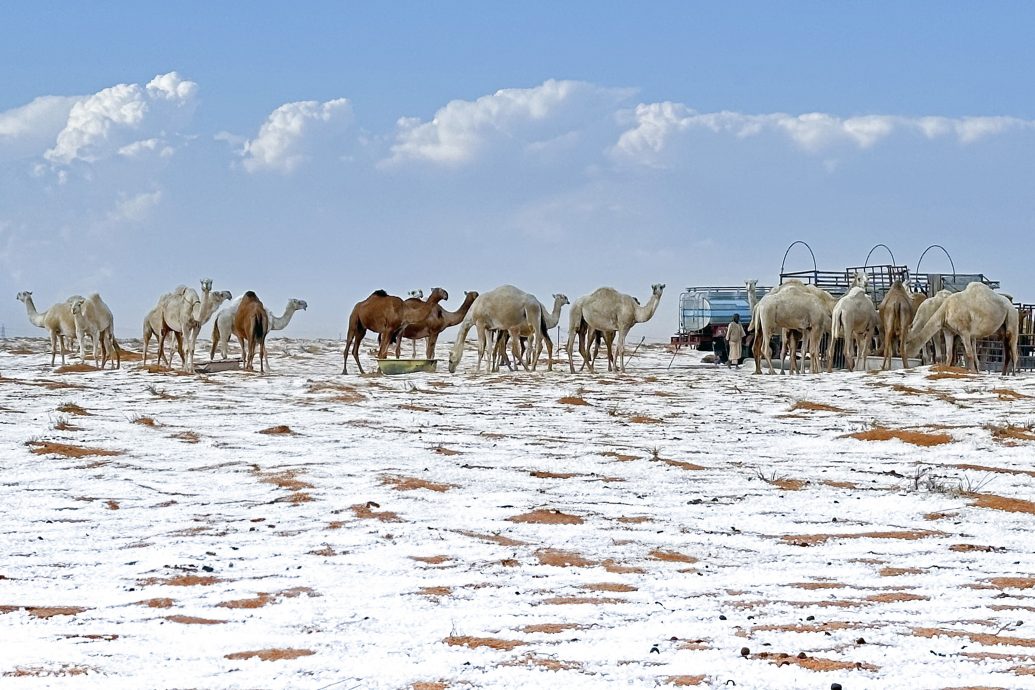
[240,98,352,173]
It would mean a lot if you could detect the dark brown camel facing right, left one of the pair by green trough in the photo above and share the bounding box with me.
[342,288,449,373]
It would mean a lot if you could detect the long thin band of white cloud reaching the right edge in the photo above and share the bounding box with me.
[611,102,1035,164]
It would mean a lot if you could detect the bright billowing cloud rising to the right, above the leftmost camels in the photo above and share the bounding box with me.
[45,71,198,166]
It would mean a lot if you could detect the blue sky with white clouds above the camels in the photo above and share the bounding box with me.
[0,2,1035,337]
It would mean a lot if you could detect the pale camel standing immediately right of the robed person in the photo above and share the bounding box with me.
[751,279,836,373]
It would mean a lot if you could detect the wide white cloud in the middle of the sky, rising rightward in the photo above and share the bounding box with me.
[388,80,631,166]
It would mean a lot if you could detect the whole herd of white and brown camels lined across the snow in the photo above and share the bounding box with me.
[18,272,1018,374]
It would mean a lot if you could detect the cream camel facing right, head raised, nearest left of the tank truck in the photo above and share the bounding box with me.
[567,282,664,372]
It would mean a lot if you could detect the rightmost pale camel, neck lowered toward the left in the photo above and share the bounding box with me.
[904,282,1019,377]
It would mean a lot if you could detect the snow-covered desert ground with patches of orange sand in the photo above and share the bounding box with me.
[0,339,1035,690]
